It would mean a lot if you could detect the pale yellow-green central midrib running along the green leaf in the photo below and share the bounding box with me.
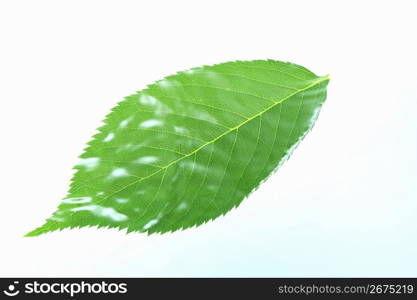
[96,75,329,203]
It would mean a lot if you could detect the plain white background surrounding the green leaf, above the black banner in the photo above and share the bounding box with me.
[0,0,417,276]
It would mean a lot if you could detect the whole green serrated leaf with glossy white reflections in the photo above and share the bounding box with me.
[27,60,329,236]
